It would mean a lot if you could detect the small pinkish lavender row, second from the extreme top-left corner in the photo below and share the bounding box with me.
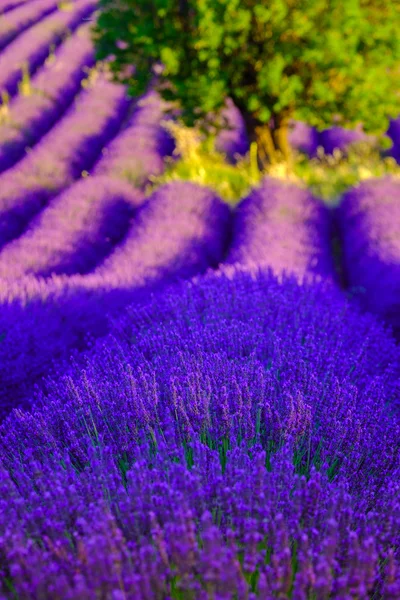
[0,0,57,50]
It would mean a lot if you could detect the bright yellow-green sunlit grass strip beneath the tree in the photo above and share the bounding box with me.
[146,122,400,204]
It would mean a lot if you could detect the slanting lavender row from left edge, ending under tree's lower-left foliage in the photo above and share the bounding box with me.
[0,74,129,247]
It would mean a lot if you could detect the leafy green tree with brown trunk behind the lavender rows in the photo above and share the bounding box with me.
[94,0,400,166]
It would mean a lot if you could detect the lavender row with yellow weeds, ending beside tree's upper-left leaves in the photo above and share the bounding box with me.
[0,25,94,171]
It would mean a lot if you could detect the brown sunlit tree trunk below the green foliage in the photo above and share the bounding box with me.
[244,109,292,171]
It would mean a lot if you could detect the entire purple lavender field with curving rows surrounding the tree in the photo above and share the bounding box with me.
[0,0,400,600]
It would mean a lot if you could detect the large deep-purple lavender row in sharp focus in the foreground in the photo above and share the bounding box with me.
[0,268,400,600]
